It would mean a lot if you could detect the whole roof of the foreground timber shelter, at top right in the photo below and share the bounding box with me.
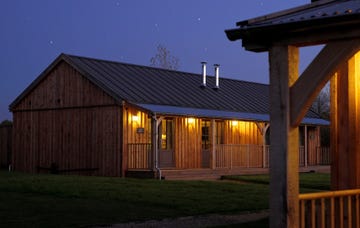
[225,0,360,52]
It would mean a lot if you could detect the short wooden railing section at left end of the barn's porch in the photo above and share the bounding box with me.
[127,143,152,169]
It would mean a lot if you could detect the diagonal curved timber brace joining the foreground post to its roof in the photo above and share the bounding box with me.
[290,39,360,126]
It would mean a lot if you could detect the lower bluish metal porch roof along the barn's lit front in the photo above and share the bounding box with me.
[134,104,329,125]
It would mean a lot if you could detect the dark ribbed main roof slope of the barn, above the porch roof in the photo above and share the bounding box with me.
[68,53,269,113]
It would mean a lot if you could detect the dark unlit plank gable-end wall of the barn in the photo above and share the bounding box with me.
[12,62,122,176]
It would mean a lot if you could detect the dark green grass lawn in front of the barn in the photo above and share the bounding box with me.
[0,171,329,227]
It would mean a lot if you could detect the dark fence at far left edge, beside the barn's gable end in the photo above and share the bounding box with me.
[0,123,12,168]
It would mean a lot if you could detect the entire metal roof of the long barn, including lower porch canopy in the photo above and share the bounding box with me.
[10,54,327,124]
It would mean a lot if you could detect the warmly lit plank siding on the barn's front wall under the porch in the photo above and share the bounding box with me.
[123,107,264,169]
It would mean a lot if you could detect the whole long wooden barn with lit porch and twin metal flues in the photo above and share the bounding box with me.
[10,54,330,179]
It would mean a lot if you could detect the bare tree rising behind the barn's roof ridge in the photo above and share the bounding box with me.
[150,44,179,70]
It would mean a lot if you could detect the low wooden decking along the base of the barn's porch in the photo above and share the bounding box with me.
[150,166,330,180]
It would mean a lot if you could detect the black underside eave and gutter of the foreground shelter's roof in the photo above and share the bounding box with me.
[225,14,360,52]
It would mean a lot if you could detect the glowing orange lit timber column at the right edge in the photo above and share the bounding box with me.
[331,52,360,190]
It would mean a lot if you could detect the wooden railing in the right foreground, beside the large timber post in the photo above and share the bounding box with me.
[299,189,360,228]
